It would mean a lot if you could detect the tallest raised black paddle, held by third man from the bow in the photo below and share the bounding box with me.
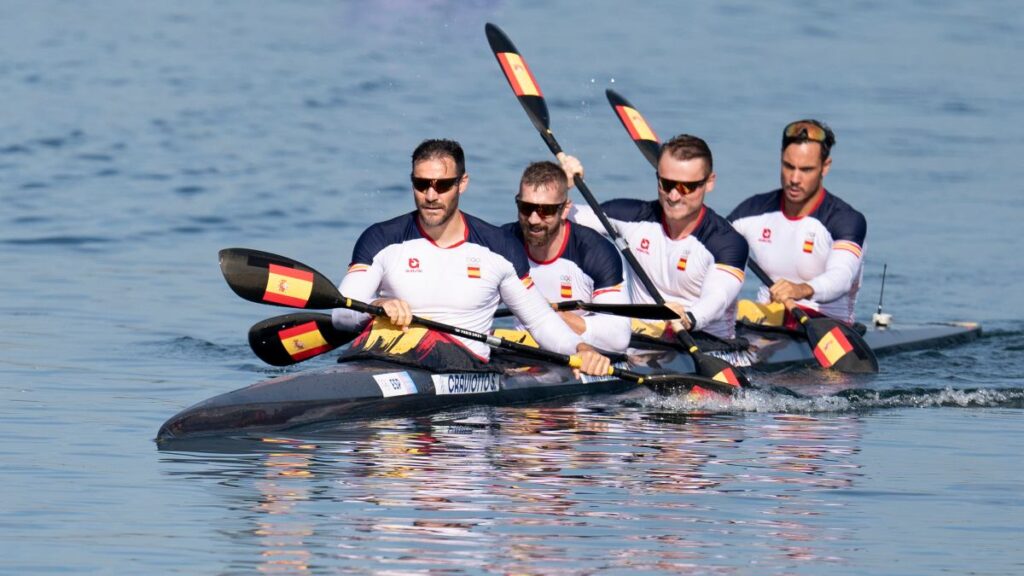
[484,23,750,386]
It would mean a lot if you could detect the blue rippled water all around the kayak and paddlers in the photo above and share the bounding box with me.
[0,0,1024,574]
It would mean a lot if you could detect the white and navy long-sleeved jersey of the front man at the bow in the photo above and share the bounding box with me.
[332,212,582,359]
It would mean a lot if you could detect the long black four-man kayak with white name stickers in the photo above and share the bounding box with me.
[151,323,981,443]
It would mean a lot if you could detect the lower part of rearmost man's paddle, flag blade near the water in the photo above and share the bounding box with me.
[746,258,879,374]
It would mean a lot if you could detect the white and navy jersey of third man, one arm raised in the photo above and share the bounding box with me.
[569,199,746,338]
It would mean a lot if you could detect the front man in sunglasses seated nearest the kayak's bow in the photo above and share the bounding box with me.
[333,139,610,375]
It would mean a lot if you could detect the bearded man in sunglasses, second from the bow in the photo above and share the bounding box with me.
[504,162,630,353]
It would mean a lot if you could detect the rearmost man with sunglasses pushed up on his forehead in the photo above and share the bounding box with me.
[729,120,867,323]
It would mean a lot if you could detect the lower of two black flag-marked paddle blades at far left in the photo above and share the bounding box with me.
[249,312,359,366]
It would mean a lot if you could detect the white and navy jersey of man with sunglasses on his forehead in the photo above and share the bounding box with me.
[729,189,867,323]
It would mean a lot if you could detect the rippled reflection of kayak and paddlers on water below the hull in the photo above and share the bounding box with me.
[164,407,860,574]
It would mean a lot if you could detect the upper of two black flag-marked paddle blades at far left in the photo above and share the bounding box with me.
[220,248,344,310]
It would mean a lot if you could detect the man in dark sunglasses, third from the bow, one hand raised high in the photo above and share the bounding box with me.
[563,134,746,338]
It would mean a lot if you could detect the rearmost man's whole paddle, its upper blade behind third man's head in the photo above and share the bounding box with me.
[604,89,879,373]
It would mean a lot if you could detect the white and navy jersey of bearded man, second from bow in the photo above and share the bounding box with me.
[503,222,630,353]
